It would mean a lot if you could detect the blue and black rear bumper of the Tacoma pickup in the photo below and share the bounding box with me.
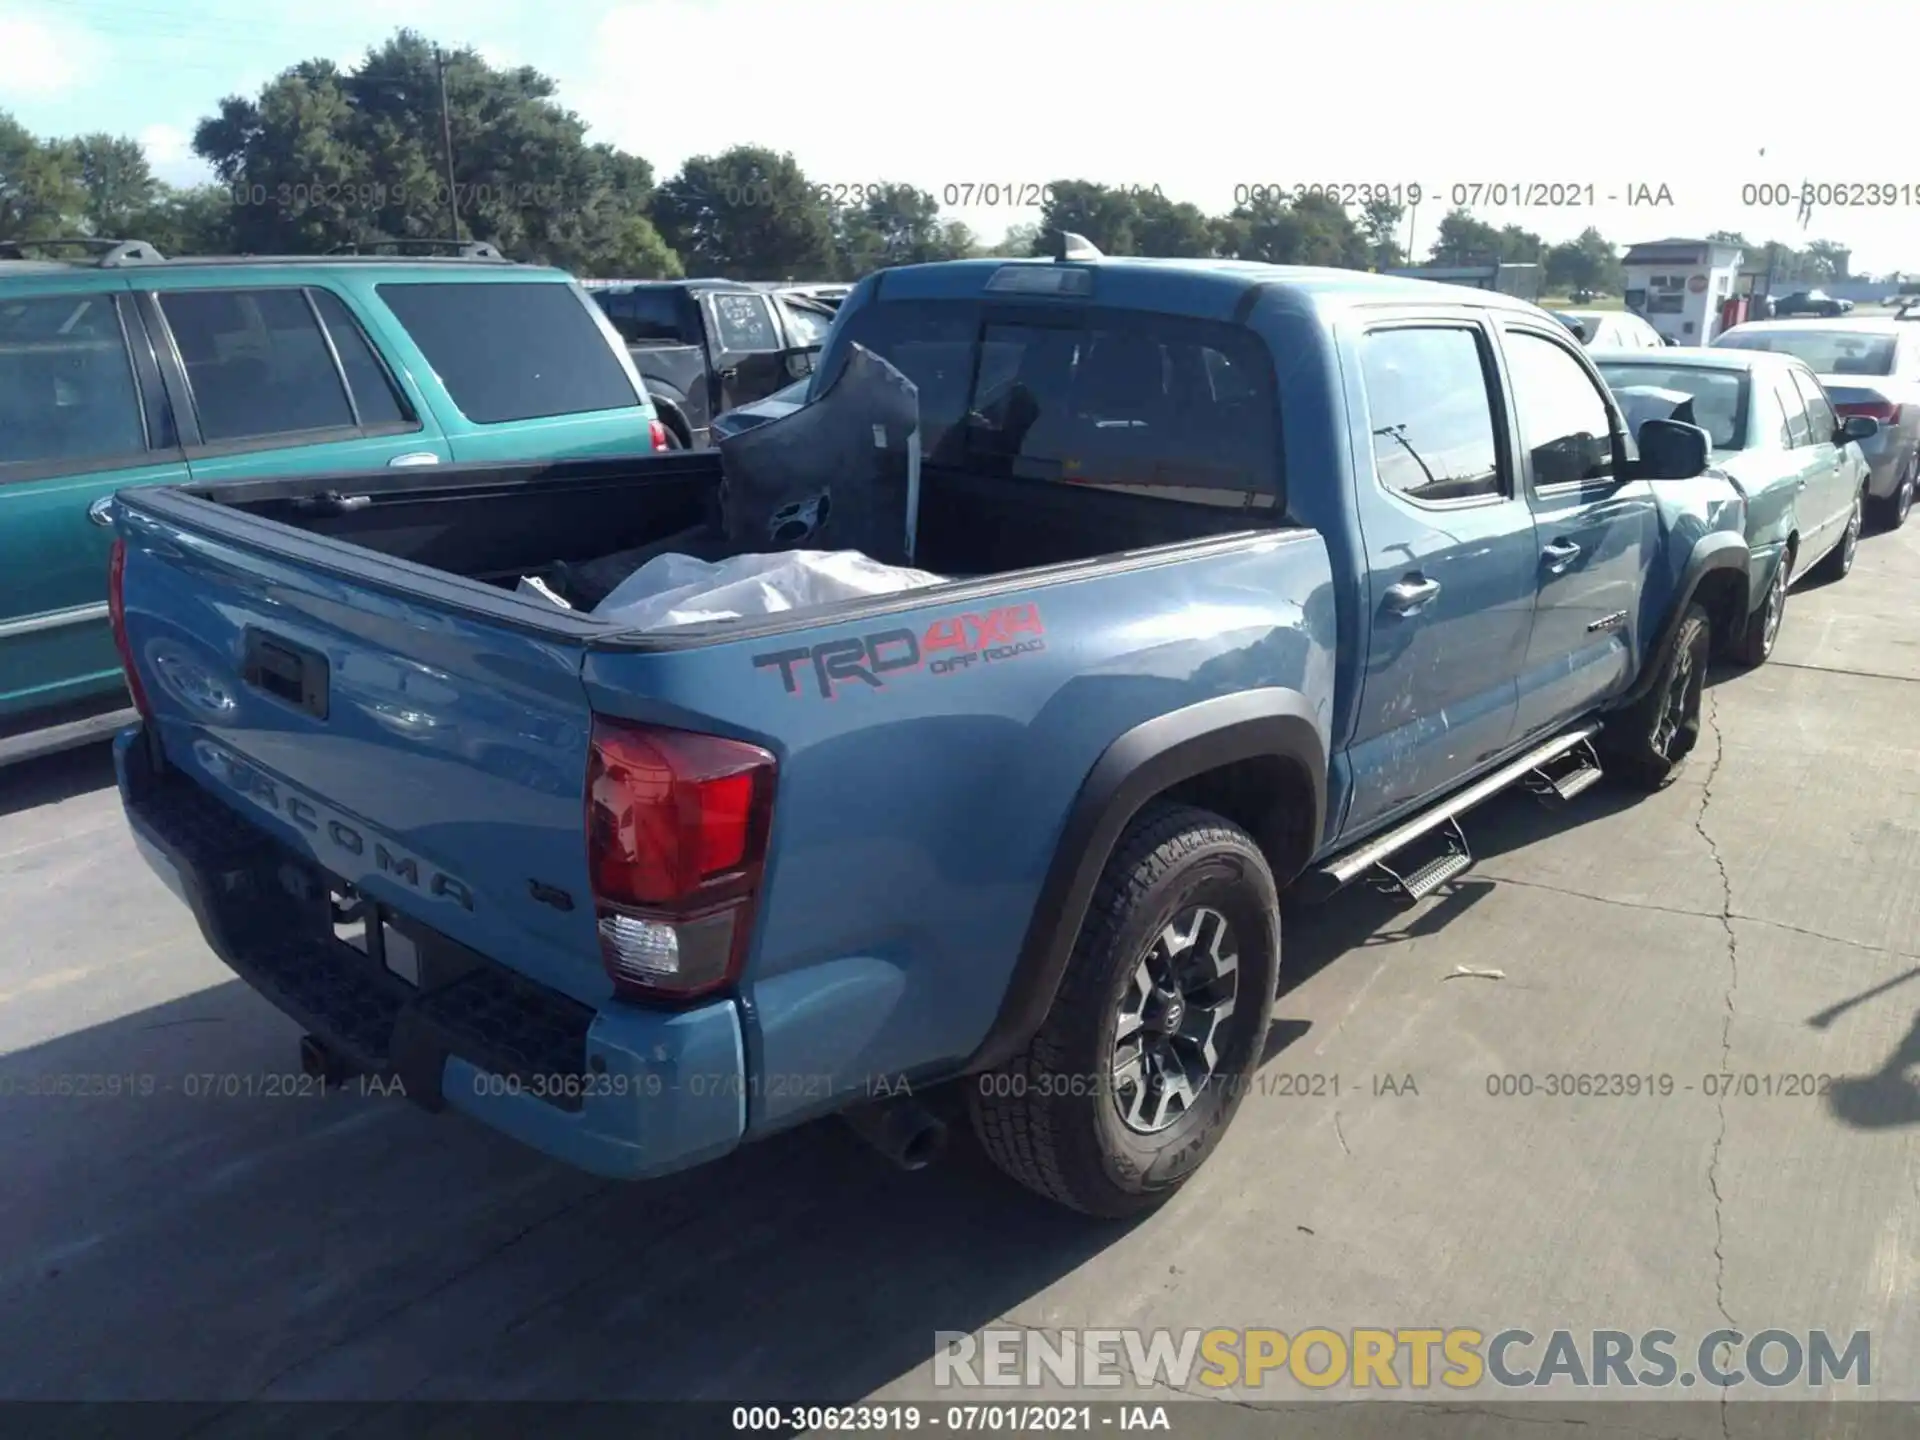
[113,726,749,1179]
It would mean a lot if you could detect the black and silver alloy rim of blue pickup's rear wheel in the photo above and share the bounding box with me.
[1114,904,1240,1135]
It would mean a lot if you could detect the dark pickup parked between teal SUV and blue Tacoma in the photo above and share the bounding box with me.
[588,280,835,449]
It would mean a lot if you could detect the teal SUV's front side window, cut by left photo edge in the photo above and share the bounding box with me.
[0,296,146,474]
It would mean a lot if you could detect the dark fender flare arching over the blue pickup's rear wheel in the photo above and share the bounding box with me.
[962,687,1327,1073]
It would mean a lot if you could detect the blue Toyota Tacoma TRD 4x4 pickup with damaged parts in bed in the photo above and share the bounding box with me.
[111,246,1749,1215]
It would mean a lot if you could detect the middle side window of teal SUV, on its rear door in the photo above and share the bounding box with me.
[159,290,353,445]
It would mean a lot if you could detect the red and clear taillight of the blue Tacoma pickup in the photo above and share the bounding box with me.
[588,716,776,1000]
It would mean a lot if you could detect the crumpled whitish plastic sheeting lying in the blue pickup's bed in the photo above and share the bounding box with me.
[593,549,943,630]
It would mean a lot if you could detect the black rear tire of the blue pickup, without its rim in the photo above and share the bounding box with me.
[966,801,1281,1219]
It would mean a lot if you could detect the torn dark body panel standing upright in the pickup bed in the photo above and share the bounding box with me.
[720,346,920,564]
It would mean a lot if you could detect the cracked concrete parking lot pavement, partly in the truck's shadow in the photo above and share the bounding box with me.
[0,524,1920,1432]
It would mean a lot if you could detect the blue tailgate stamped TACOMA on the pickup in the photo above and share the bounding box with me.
[121,495,611,1004]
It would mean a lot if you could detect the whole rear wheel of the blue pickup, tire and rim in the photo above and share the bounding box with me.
[968,803,1281,1217]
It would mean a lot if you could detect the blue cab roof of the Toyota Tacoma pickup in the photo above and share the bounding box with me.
[876,257,1538,328]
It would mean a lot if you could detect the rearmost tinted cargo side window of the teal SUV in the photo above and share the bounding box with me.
[380,282,639,424]
